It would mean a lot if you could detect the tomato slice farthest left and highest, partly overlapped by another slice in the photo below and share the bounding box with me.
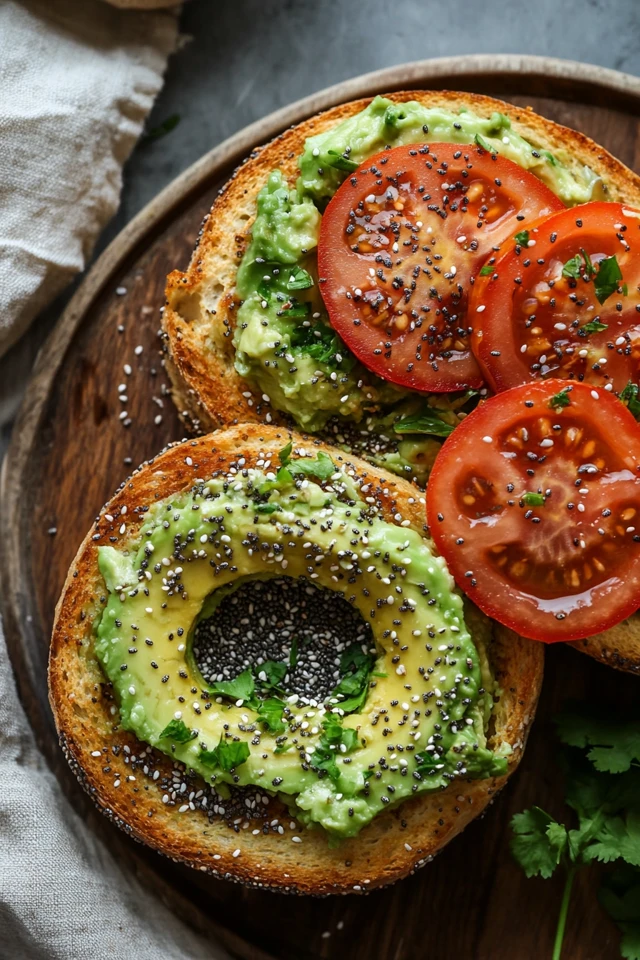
[318,143,563,392]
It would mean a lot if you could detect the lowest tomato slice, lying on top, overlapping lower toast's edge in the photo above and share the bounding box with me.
[427,380,640,643]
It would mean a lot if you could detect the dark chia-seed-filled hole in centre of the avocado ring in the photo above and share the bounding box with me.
[192,577,375,703]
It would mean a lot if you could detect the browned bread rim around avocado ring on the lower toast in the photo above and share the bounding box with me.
[49,424,543,894]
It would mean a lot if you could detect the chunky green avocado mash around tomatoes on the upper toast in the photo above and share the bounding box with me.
[234,97,602,472]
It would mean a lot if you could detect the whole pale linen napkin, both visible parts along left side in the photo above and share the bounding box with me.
[0,0,227,960]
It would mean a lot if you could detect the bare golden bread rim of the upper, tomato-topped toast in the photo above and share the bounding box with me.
[163,90,640,673]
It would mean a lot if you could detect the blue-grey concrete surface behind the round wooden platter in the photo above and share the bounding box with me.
[0,0,640,446]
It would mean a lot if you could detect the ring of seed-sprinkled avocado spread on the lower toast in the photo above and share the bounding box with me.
[95,445,510,837]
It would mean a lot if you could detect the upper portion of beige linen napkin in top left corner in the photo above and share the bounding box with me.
[0,0,177,355]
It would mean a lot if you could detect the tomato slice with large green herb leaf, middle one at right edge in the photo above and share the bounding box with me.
[469,202,640,392]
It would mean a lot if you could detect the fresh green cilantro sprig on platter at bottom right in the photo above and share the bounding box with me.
[511,710,640,960]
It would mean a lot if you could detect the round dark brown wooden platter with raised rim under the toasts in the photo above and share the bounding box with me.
[0,56,640,960]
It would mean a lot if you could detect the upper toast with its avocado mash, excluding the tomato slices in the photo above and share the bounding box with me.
[163,91,640,672]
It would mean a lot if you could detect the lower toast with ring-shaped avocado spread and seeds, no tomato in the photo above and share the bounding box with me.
[50,425,542,893]
